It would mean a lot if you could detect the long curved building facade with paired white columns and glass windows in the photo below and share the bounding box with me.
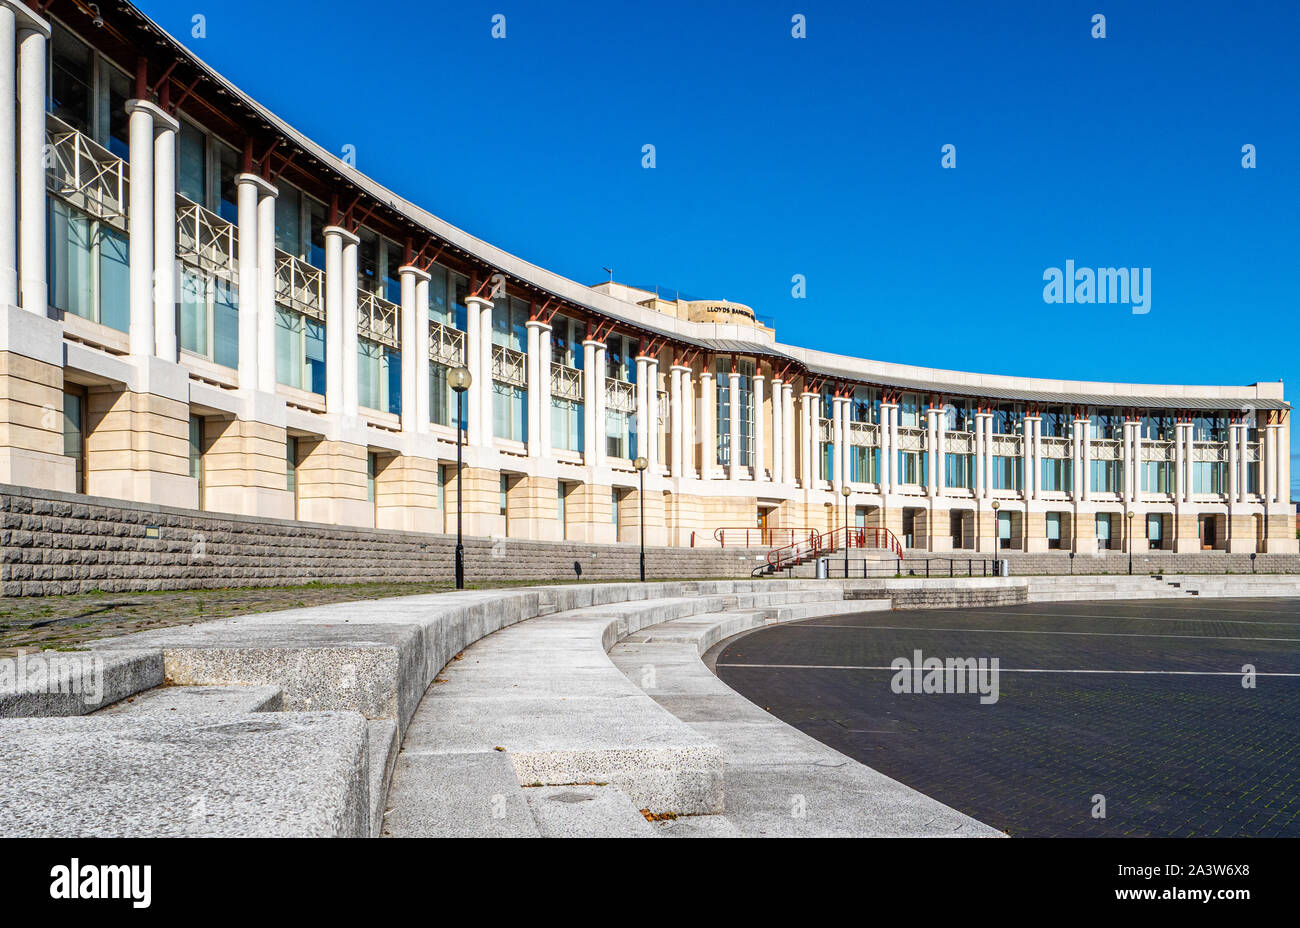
[0,0,1296,554]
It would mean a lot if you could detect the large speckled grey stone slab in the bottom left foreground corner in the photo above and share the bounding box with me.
[0,712,369,837]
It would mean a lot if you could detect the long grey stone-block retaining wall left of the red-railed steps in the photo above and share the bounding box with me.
[0,485,762,597]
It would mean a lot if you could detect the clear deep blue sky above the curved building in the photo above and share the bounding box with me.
[138,0,1300,496]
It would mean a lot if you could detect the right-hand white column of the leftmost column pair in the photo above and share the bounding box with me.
[9,17,46,310]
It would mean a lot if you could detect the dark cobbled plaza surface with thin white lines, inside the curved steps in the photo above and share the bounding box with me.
[718,599,1300,837]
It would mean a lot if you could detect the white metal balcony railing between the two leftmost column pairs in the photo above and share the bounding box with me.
[46,113,129,230]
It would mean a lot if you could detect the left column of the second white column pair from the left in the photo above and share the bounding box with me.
[127,100,157,356]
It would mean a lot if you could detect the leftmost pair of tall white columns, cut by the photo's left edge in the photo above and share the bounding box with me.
[0,0,49,316]
